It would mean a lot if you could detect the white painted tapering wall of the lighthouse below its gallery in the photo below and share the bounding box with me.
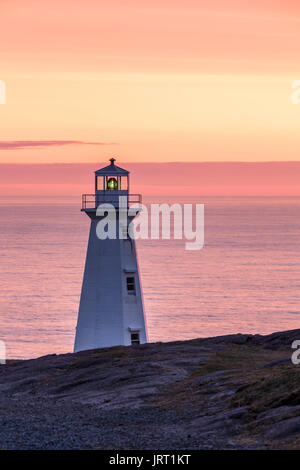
[74,212,147,352]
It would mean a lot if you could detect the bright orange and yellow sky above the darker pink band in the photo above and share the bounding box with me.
[0,0,300,166]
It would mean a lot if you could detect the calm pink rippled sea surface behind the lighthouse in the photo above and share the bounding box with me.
[0,197,300,358]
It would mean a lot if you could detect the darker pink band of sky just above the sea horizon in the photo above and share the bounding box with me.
[0,162,300,196]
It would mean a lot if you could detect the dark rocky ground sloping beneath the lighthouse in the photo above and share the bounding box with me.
[0,330,300,450]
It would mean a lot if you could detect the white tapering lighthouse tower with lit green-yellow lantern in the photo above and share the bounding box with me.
[74,158,147,352]
